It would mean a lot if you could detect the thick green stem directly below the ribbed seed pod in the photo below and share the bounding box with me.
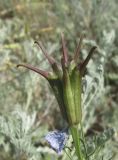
[70,125,84,160]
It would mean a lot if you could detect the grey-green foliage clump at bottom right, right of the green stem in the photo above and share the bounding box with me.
[78,128,114,160]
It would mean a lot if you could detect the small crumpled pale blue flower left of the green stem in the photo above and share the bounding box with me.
[45,129,68,154]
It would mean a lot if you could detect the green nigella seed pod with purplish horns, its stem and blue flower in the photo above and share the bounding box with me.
[17,34,96,160]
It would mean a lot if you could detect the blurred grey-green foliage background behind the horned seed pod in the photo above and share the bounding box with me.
[0,0,118,160]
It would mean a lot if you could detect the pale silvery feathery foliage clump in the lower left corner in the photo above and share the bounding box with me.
[0,110,37,157]
